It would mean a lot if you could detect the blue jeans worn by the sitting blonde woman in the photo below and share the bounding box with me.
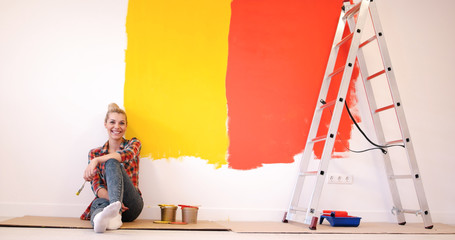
[90,159,144,226]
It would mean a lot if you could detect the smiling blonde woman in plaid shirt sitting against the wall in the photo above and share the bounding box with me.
[81,103,144,233]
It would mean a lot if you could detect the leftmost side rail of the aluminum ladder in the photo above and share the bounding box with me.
[286,7,345,220]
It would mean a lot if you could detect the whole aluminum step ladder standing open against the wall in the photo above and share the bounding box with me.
[283,0,433,230]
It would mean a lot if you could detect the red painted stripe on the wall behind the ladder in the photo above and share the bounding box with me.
[226,0,358,169]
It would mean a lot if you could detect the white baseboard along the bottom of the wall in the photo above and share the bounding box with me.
[0,203,455,225]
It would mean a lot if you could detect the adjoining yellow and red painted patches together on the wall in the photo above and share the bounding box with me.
[124,0,358,170]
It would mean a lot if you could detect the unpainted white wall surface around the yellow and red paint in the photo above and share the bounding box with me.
[0,0,455,224]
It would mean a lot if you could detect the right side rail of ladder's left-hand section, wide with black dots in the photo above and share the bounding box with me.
[305,0,369,224]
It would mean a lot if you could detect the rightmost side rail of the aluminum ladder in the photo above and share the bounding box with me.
[370,2,433,228]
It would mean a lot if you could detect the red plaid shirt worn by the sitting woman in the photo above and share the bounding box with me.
[80,138,141,220]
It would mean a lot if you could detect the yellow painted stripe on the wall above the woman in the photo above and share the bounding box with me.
[124,0,231,167]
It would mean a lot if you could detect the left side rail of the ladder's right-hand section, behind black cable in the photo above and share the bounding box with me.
[348,15,406,224]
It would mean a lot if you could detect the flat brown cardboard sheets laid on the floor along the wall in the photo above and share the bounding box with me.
[0,216,455,234]
